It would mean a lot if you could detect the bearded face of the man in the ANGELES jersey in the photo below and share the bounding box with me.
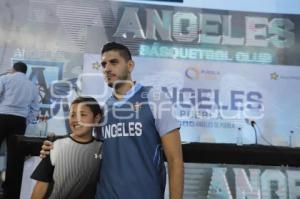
[101,50,133,87]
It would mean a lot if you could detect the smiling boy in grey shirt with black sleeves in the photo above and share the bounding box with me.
[31,97,103,199]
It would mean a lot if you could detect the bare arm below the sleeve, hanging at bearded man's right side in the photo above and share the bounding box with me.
[161,129,184,199]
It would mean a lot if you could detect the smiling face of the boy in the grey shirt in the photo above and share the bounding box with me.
[69,103,100,138]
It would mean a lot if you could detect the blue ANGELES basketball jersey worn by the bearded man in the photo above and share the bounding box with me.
[96,84,179,199]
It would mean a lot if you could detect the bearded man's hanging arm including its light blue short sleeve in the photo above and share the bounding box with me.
[148,88,183,199]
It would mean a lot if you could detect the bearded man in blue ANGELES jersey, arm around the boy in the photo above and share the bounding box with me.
[42,42,183,199]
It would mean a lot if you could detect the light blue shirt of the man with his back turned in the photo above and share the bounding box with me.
[0,72,39,122]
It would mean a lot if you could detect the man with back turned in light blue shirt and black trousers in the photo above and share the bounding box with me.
[0,62,39,199]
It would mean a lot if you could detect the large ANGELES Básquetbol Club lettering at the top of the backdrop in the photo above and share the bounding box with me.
[105,0,299,64]
